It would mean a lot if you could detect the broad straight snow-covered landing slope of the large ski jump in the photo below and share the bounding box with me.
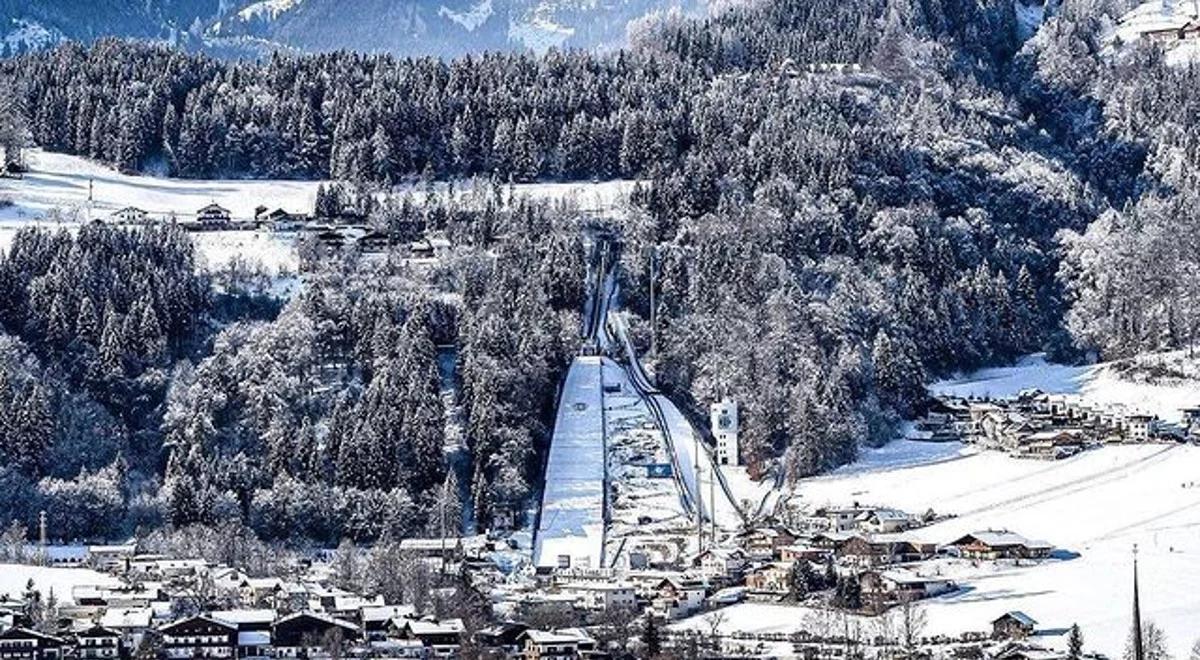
[534,355,606,568]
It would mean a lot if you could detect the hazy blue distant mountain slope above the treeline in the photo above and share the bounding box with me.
[0,0,706,56]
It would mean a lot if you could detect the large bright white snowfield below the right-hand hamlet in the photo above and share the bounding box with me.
[683,440,1200,656]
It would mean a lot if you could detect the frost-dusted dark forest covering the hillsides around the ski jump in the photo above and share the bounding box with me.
[0,0,1200,544]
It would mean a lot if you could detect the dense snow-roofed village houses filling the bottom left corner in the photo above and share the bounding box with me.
[0,536,625,660]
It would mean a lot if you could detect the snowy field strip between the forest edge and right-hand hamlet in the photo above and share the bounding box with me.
[929,355,1200,421]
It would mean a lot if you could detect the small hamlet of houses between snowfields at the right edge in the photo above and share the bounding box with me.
[911,390,1200,458]
